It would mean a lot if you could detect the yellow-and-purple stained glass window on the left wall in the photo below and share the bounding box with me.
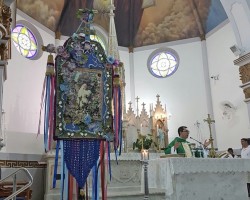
[11,24,38,59]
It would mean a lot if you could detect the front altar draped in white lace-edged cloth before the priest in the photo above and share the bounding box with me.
[148,158,250,200]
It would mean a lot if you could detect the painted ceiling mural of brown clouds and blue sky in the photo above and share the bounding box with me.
[17,0,227,47]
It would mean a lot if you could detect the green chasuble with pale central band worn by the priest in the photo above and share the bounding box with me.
[164,137,192,157]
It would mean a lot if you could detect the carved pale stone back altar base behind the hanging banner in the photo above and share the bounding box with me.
[44,151,163,200]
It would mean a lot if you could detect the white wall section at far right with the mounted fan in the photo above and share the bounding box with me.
[206,23,249,149]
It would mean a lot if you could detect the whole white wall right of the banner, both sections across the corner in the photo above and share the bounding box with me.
[127,23,249,150]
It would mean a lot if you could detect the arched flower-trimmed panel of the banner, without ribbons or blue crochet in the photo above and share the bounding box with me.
[55,34,113,139]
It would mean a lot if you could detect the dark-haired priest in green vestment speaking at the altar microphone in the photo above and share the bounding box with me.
[164,126,210,158]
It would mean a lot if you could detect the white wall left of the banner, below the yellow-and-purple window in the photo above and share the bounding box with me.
[3,15,54,154]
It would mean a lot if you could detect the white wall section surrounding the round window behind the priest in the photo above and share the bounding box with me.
[131,40,211,143]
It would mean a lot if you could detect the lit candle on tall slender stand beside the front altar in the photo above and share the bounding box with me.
[141,148,149,199]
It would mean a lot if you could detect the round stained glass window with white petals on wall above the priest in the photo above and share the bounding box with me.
[148,48,179,78]
